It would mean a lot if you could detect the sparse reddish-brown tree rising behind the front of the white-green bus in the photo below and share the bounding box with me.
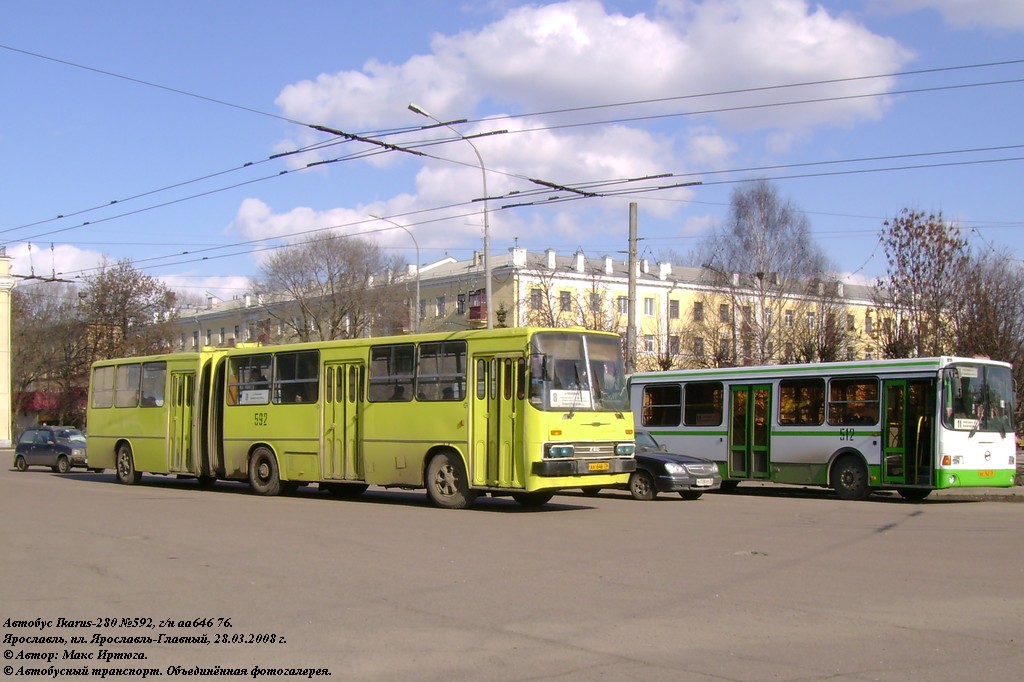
[874,209,970,357]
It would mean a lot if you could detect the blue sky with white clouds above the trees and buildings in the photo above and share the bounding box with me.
[0,0,1024,298]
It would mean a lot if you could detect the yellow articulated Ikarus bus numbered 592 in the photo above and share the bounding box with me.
[88,328,636,509]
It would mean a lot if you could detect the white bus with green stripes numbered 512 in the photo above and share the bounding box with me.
[630,357,1016,500]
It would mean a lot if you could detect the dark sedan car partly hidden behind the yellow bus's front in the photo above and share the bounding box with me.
[584,431,722,500]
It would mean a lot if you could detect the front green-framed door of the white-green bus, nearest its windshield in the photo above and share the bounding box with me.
[882,379,935,485]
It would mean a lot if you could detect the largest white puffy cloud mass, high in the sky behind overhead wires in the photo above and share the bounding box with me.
[268,0,912,251]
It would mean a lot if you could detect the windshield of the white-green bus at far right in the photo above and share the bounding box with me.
[942,364,1014,435]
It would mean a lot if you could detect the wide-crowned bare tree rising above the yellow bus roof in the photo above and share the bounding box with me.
[252,233,409,341]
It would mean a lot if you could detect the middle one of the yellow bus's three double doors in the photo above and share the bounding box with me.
[321,363,365,480]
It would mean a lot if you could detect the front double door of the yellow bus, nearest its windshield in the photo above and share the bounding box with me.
[469,355,525,487]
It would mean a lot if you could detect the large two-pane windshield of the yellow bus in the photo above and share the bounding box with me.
[529,332,627,412]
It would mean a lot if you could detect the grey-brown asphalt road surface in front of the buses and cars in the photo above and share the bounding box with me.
[0,456,1024,682]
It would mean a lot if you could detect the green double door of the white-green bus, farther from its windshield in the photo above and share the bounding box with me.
[728,384,771,478]
